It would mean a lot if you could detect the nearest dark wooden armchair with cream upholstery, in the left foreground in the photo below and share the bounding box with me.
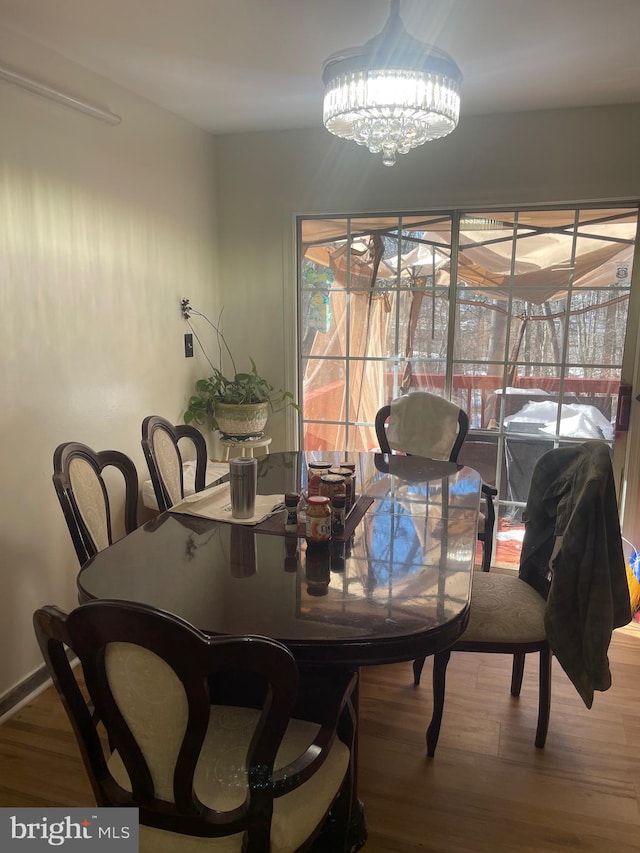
[34,600,357,853]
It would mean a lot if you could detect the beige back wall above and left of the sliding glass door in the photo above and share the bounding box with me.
[217,105,640,520]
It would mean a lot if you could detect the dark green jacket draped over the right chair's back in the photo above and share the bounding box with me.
[520,441,631,708]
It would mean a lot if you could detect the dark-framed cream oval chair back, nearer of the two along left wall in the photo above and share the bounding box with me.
[53,442,138,566]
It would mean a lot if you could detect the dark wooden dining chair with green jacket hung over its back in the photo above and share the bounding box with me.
[414,441,631,756]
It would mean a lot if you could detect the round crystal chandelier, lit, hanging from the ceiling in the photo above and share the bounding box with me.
[322,0,462,166]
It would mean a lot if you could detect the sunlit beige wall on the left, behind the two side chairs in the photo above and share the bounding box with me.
[0,30,217,697]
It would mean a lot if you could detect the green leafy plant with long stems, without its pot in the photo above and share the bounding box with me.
[181,299,299,429]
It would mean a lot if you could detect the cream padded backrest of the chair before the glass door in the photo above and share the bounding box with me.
[375,391,469,462]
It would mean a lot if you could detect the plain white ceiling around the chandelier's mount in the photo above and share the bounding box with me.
[0,0,640,133]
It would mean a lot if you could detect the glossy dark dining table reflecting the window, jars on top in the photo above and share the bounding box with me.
[78,452,481,853]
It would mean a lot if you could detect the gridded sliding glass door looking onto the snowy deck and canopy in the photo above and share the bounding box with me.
[298,206,638,565]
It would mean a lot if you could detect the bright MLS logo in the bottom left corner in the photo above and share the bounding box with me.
[0,807,138,853]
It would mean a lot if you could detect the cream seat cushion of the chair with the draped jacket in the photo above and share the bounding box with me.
[459,572,546,643]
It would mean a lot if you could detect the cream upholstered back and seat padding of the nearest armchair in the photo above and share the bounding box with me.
[105,643,349,853]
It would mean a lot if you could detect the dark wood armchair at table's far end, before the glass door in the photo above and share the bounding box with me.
[375,391,498,572]
